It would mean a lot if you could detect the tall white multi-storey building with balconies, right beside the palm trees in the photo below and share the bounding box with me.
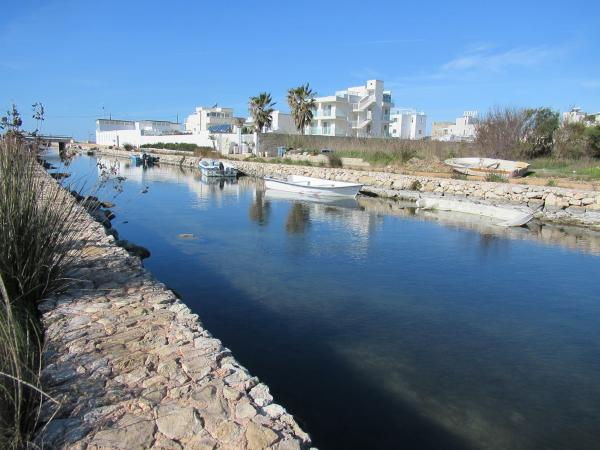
[306,80,394,137]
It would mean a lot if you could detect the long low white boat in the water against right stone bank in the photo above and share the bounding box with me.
[417,198,533,227]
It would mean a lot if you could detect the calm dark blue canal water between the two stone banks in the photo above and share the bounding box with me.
[48,152,600,449]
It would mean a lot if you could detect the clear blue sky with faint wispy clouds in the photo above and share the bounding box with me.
[0,0,600,139]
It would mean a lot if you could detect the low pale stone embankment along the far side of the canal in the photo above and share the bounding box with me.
[91,149,600,229]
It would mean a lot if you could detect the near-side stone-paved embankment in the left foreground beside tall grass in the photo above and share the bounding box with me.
[38,174,310,450]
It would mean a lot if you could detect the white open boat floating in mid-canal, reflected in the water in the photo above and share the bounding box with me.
[265,175,362,197]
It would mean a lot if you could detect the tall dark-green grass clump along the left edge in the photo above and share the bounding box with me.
[0,136,83,449]
